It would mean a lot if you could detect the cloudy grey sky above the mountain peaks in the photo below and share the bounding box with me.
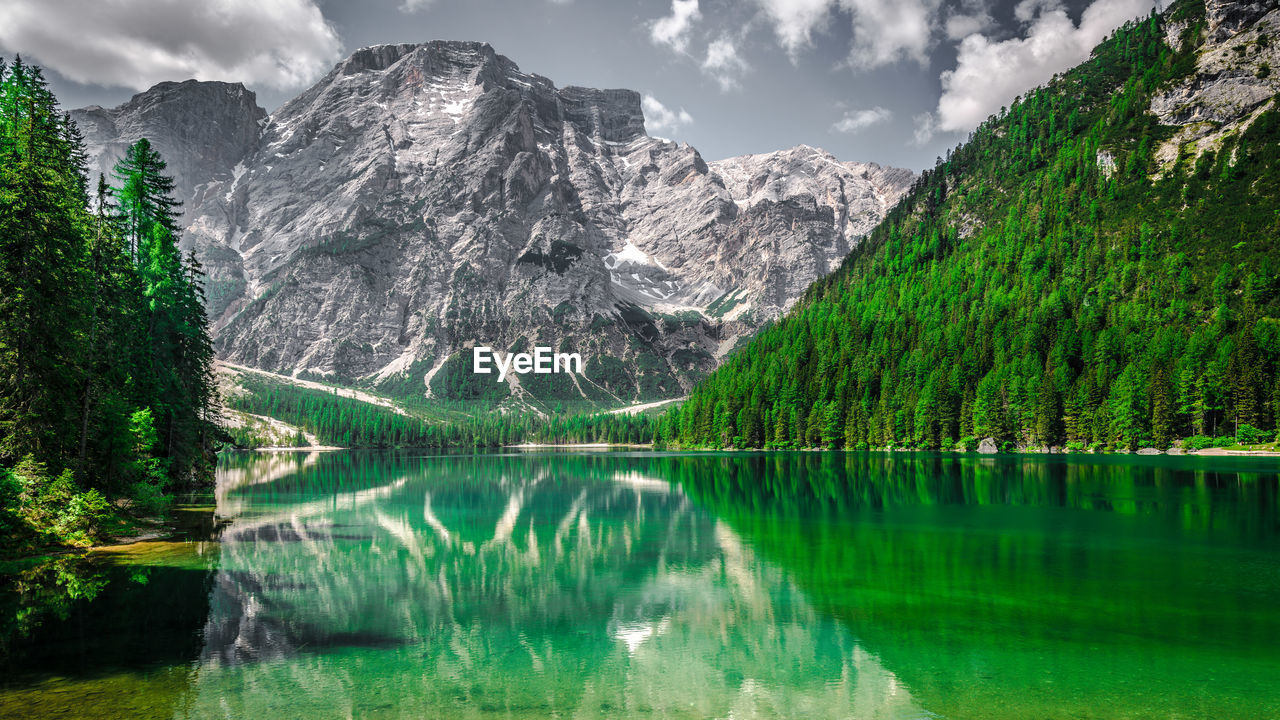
[0,0,1156,170]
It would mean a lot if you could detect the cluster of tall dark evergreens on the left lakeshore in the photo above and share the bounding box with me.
[0,59,216,551]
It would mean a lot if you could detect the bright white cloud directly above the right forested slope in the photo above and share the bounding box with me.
[934,0,1155,132]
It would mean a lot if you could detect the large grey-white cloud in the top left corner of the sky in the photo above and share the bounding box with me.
[0,0,342,90]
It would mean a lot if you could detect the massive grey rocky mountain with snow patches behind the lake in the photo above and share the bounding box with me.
[76,42,914,407]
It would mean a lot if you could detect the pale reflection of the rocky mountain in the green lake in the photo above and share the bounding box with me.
[188,455,927,717]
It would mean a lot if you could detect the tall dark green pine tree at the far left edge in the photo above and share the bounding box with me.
[0,59,86,458]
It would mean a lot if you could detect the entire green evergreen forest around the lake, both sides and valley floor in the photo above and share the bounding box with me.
[0,0,1280,548]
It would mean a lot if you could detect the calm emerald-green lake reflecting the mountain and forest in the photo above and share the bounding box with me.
[0,452,1280,720]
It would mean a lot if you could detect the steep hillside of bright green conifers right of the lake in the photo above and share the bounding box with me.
[659,0,1280,448]
